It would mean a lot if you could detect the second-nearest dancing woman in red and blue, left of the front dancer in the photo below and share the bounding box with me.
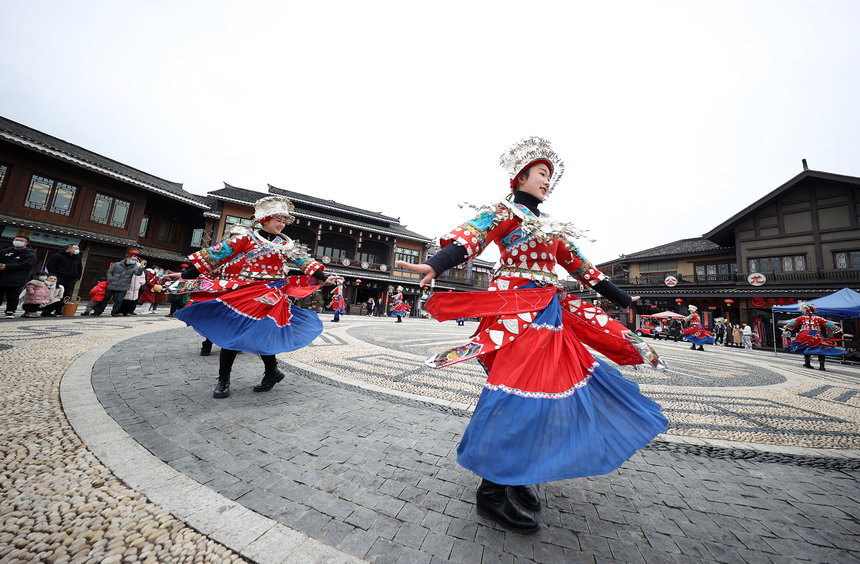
[170,196,342,398]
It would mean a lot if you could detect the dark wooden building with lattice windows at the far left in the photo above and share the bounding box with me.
[0,117,209,300]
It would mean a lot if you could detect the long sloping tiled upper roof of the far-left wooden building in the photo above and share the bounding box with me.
[0,116,208,209]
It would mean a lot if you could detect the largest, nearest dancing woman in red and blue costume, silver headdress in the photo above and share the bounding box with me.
[397,137,667,534]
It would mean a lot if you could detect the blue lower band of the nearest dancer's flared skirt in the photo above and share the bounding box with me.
[457,362,668,485]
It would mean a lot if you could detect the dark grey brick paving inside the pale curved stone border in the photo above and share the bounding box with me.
[93,324,860,563]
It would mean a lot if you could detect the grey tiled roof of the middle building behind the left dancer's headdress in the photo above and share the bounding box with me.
[209,182,431,242]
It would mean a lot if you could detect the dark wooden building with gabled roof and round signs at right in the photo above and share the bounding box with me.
[597,165,860,343]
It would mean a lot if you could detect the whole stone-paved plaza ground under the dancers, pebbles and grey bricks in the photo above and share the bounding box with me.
[0,316,860,562]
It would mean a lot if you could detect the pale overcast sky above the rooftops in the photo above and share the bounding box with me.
[0,0,860,262]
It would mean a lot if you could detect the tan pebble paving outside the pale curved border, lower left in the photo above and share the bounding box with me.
[0,316,245,564]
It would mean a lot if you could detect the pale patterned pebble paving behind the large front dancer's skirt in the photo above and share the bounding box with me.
[330,317,860,449]
